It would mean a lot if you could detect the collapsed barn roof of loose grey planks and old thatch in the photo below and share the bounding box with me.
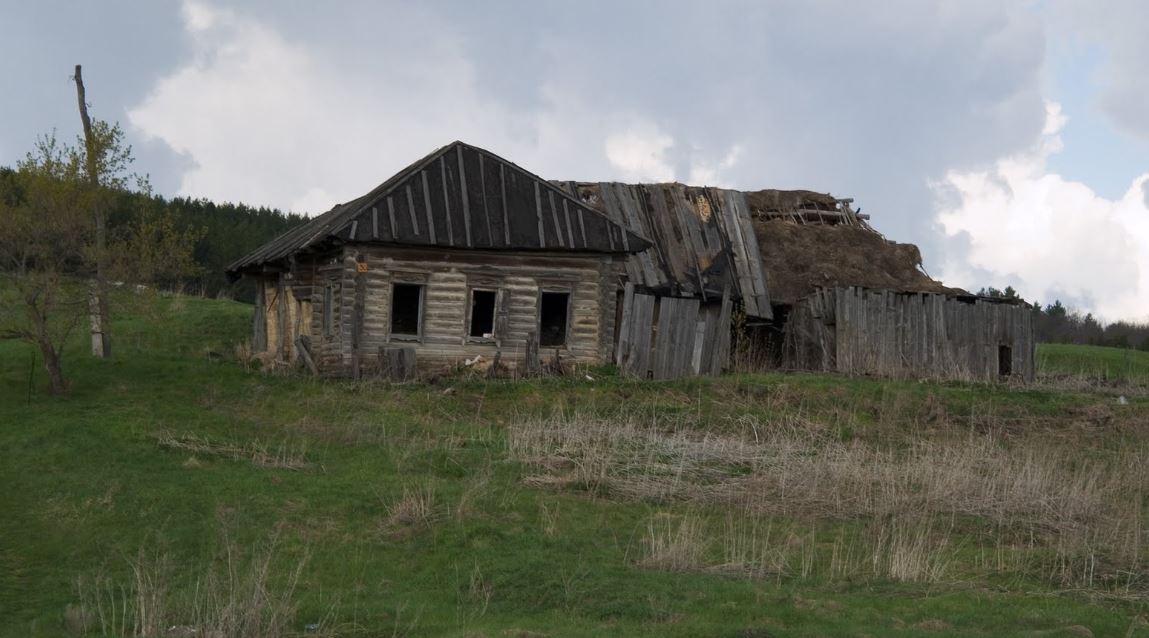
[561,182,969,318]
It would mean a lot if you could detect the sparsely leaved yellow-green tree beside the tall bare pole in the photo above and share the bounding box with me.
[0,129,198,394]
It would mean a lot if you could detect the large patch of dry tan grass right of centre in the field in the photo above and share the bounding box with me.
[508,415,1149,587]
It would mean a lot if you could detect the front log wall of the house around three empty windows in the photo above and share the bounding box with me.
[310,245,618,376]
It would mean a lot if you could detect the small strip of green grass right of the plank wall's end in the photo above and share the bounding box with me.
[1038,344,1149,385]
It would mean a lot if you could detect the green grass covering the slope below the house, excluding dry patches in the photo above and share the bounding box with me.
[0,291,1149,637]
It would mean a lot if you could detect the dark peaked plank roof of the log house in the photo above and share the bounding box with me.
[228,141,650,276]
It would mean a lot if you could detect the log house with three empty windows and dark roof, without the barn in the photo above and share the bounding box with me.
[229,141,650,377]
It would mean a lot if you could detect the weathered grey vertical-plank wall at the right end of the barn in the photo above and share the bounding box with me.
[785,287,1035,382]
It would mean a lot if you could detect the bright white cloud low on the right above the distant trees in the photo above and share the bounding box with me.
[933,103,1149,318]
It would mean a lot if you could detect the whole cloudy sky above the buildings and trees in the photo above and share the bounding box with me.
[0,0,1149,320]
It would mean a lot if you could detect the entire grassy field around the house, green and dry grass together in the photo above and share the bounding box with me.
[0,291,1149,637]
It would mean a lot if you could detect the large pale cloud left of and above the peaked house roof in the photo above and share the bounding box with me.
[129,2,511,213]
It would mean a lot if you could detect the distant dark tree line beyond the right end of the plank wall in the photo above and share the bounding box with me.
[978,286,1149,351]
